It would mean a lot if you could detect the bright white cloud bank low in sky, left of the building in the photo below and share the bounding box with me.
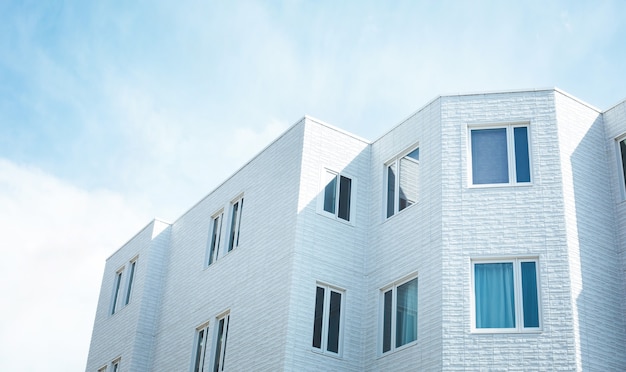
[0,159,148,371]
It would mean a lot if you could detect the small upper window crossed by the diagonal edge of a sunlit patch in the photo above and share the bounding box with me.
[318,170,353,221]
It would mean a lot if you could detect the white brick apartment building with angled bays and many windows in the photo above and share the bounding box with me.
[87,89,626,372]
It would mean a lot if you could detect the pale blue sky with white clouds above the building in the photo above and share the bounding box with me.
[0,0,626,372]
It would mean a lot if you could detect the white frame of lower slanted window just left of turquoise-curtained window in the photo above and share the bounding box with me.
[377,273,420,356]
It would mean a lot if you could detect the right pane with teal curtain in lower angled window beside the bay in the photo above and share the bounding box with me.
[396,278,417,347]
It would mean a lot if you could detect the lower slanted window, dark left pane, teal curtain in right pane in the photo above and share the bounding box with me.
[381,278,417,353]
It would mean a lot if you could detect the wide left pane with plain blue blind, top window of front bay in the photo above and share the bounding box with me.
[471,128,509,185]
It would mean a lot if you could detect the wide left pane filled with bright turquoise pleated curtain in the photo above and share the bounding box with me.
[474,262,515,328]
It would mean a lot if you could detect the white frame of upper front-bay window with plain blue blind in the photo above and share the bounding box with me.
[467,121,534,188]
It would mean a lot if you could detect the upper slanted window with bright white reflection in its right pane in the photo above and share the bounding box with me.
[386,148,420,217]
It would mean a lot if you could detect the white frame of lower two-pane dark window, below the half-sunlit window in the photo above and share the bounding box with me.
[311,282,346,357]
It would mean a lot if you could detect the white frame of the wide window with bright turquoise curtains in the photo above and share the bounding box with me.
[470,256,543,333]
